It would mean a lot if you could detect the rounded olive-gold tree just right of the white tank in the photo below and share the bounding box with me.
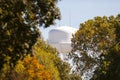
[70,15,119,77]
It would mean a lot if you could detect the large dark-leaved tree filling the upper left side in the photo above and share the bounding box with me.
[0,0,60,70]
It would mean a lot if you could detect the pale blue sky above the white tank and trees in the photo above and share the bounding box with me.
[40,0,120,40]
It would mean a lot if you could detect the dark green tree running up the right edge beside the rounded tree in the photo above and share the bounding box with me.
[91,15,120,80]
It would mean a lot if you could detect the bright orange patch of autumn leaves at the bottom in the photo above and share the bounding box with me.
[18,56,51,80]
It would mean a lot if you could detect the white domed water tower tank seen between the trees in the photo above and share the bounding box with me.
[48,26,77,53]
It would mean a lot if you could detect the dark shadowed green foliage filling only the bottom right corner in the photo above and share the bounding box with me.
[91,43,120,80]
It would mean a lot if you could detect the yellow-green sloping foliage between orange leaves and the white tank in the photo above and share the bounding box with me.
[34,40,73,80]
